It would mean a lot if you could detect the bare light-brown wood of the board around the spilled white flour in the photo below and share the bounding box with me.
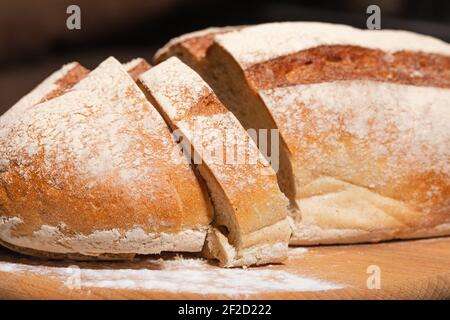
[0,237,450,299]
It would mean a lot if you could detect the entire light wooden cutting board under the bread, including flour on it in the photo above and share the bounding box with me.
[0,238,450,299]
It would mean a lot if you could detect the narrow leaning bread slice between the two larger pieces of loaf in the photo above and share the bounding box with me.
[139,58,291,267]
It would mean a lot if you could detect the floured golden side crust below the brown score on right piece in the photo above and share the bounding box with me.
[260,81,450,243]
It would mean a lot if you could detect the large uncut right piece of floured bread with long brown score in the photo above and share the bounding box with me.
[156,22,450,244]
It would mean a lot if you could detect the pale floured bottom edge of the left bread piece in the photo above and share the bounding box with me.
[0,217,207,258]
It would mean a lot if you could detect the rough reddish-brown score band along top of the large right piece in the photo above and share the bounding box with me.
[245,45,450,90]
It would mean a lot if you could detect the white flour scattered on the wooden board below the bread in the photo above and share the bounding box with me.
[0,249,343,296]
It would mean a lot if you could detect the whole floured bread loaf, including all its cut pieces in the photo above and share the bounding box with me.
[0,22,450,267]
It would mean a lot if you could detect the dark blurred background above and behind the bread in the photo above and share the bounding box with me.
[0,0,450,114]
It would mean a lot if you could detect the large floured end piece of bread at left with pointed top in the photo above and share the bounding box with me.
[0,58,212,259]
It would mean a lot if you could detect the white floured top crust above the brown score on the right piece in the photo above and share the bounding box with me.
[214,22,450,69]
